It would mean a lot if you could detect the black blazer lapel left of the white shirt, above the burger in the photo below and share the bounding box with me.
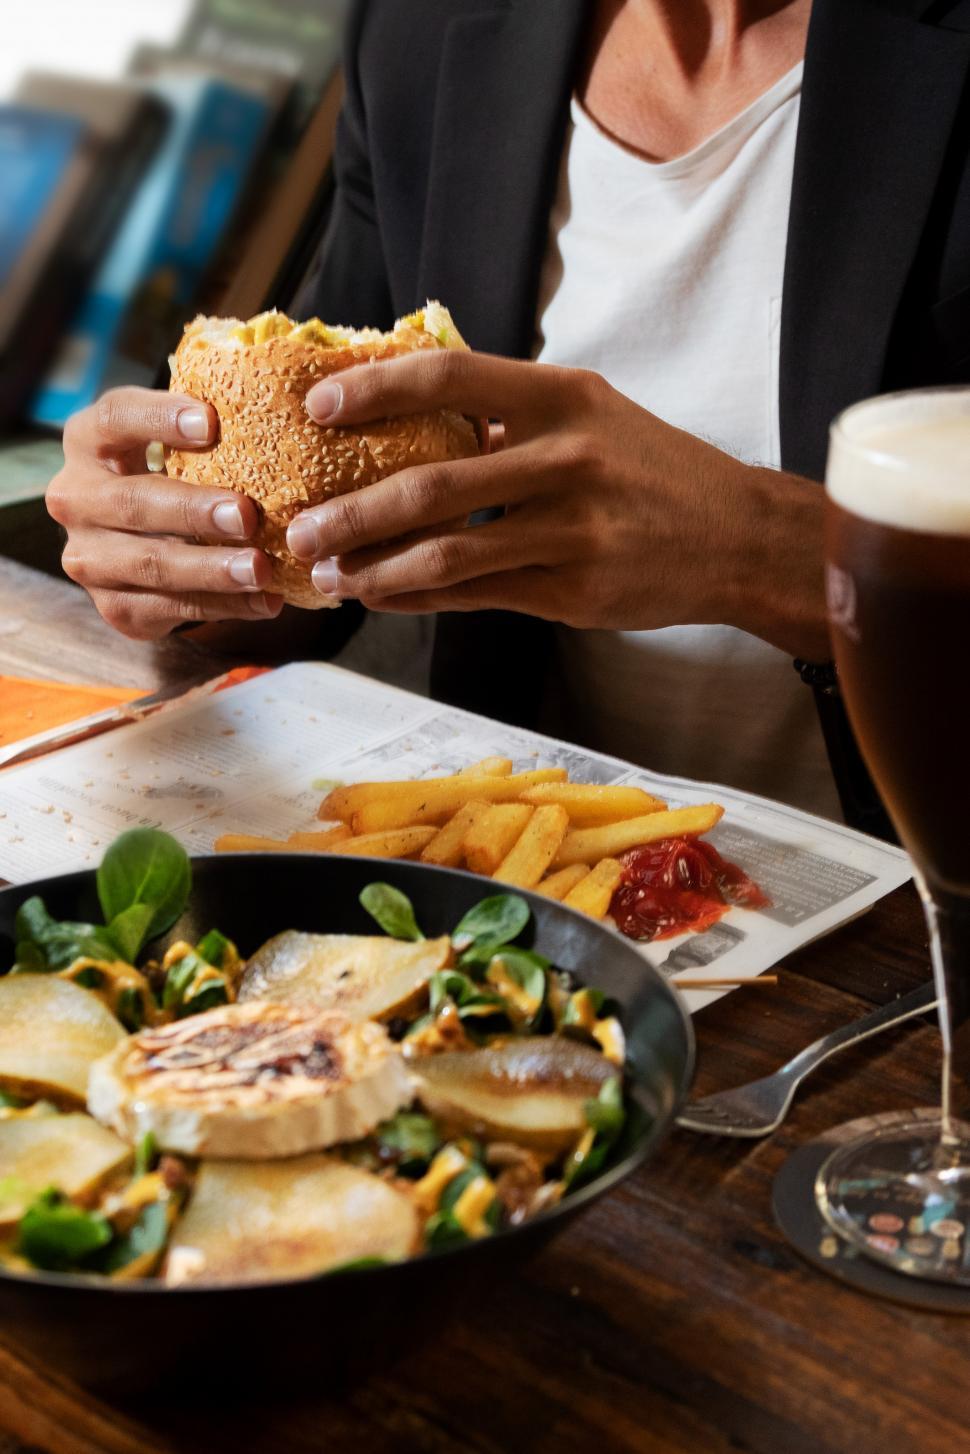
[417,0,586,356]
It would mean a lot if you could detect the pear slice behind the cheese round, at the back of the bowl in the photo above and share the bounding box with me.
[239,929,452,1021]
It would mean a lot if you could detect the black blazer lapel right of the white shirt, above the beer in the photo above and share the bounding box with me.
[779,0,970,478]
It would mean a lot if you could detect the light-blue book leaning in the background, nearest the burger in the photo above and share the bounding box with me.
[29,76,269,427]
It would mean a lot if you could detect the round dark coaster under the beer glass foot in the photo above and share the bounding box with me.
[771,1111,970,1313]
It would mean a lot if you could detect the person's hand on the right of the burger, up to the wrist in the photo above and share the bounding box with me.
[288,350,829,656]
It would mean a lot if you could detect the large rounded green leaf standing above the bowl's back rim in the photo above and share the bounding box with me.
[97,827,192,939]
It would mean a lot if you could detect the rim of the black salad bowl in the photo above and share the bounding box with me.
[0,851,697,1300]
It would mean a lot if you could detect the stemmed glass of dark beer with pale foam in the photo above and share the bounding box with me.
[816,388,970,1284]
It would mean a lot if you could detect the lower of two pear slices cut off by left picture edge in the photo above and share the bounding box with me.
[0,1112,132,1232]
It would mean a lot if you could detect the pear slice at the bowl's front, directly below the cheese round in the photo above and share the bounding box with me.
[163,1153,419,1287]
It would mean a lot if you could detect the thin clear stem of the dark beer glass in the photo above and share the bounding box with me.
[923,893,970,1147]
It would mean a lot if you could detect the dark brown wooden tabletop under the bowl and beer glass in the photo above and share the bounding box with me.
[0,563,970,1454]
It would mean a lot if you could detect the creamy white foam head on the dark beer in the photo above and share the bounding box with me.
[826,388,970,535]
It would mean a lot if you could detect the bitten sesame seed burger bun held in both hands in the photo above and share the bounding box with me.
[166,304,478,609]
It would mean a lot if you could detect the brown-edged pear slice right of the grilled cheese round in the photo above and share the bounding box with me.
[410,1035,617,1153]
